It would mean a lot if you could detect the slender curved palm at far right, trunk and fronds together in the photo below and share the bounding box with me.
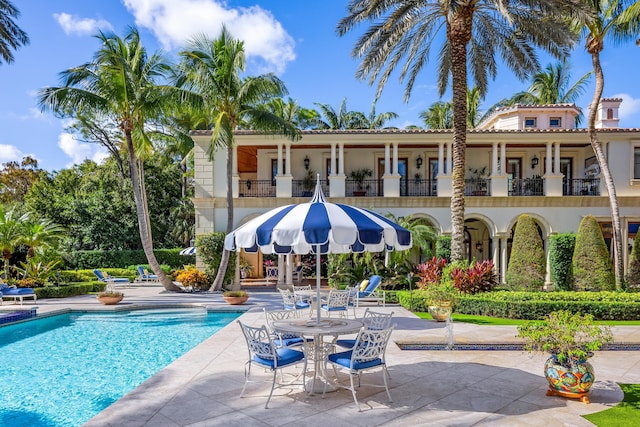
[583,0,640,289]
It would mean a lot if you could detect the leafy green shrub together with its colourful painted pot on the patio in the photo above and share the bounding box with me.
[517,311,613,403]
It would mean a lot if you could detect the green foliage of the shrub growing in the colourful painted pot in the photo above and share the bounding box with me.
[518,311,613,367]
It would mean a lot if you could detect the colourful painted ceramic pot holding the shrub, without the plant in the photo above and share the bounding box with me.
[544,355,595,403]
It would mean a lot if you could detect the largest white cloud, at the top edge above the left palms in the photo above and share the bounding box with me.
[123,0,295,74]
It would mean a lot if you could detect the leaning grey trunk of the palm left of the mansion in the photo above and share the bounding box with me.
[125,131,181,291]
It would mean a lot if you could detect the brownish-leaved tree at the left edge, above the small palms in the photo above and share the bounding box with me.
[0,156,45,203]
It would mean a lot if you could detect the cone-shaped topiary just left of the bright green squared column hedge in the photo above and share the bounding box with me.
[506,214,546,291]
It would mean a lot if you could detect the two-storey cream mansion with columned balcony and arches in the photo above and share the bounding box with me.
[191,98,640,284]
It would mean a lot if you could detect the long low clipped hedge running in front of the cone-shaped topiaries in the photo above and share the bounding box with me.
[397,291,640,320]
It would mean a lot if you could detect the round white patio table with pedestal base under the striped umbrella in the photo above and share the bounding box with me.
[272,318,364,393]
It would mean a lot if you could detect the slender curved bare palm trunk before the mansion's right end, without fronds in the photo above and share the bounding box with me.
[588,50,624,290]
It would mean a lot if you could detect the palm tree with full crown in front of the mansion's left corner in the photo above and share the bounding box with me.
[177,27,300,290]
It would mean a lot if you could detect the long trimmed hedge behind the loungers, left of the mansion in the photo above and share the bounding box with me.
[62,248,196,270]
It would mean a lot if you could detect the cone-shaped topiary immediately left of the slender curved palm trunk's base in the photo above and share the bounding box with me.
[573,215,616,291]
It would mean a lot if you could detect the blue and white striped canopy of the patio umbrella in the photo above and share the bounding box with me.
[224,181,411,254]
